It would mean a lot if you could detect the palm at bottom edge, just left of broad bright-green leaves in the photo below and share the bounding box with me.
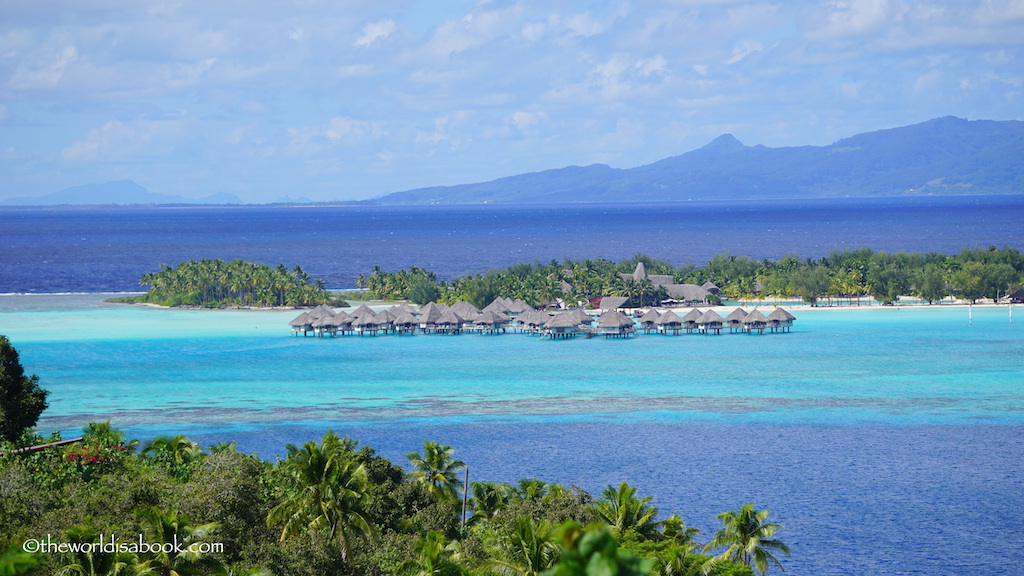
[483,517,561,576]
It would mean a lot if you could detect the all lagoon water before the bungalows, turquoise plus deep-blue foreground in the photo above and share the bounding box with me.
[0,294,1024,575]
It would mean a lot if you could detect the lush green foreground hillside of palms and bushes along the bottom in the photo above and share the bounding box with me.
[0,416,787,576]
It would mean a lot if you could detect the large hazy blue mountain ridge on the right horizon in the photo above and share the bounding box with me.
[368,116,1024,205]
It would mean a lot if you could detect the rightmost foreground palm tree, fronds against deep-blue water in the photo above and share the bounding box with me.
[705,503,790,574]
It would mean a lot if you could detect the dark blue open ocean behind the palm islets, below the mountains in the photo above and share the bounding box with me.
[6,196,1024,293]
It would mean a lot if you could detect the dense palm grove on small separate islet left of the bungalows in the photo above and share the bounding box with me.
[134,259,338,307]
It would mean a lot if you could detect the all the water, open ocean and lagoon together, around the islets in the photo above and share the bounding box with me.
[0,196,1024,576]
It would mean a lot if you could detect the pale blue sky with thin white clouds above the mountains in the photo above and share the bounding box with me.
[0,0,1024,203]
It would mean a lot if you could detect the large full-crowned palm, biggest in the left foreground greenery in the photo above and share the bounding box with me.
[266,431,376,558]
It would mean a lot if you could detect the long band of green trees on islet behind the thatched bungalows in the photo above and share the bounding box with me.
[360,246,1024,307]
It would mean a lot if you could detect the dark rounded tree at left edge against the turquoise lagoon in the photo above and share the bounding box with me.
[0,335,50,442]
